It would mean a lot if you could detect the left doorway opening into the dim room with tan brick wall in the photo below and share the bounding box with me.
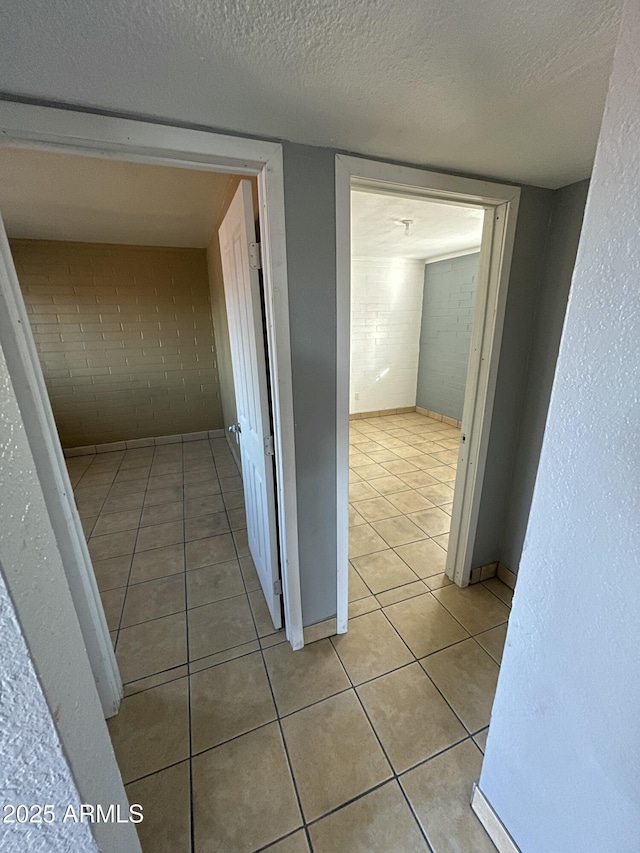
[0,136,301,716]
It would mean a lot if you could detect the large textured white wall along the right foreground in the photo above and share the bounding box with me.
[480,2,640,853]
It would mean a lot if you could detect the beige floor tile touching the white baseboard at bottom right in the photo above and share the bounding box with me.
[400,740,496,853]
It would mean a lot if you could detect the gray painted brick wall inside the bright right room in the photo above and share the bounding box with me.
[417,252,480,420]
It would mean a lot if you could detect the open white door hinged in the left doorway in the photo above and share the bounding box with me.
[218,181,282,628]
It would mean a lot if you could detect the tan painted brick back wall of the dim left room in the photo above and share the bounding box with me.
[11,240,222,447]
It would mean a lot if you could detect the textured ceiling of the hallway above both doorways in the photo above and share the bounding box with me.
[0,0,621,187]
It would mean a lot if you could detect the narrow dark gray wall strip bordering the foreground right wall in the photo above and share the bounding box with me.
[500,181,589,572]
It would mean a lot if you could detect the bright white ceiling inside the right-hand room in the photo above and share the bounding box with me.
[351,191,484,261]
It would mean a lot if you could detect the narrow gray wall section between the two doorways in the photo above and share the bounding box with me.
[284,143,337,625]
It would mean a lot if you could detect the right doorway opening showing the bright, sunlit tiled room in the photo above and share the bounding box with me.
[349,186,485,614]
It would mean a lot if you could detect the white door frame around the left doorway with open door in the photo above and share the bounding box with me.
[0,101,304,716]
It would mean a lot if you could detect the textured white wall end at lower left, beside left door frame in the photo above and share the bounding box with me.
[0,332,140,853]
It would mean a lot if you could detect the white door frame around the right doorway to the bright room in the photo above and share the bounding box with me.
[336,154,520,633]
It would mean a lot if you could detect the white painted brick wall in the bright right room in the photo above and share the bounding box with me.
[350,258,424,414]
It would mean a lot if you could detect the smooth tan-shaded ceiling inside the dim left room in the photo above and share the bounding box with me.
[0,148,237,248]
